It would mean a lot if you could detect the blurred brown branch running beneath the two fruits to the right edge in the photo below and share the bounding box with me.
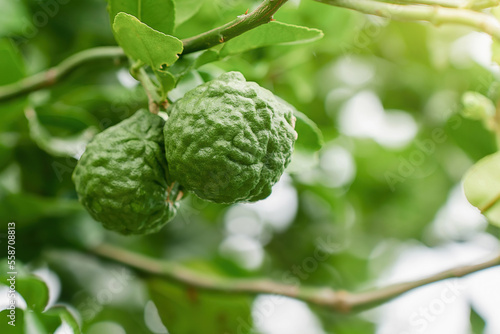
[91,244,500,313]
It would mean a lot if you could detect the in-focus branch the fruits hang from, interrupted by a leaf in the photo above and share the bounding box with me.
[0,0,288,102]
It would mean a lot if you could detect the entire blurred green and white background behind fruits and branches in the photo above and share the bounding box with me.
[0,0,500,334]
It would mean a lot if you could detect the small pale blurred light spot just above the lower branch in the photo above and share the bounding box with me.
[219,235,264,270]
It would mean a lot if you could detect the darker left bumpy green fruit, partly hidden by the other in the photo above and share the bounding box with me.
[73,109,177,234]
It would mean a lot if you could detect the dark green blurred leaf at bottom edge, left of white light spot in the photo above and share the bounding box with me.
[148,279,252,334]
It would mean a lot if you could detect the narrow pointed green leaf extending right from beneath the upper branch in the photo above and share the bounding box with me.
[220,21,323,57]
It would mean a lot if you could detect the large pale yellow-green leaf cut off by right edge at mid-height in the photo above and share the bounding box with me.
[464,152,500,226]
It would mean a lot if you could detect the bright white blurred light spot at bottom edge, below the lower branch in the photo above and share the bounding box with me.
[252,295,325,334]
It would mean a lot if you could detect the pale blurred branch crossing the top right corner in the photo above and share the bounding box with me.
[315,0,500,41]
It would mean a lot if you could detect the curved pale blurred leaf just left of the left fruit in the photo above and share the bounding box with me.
[25,109,98,157]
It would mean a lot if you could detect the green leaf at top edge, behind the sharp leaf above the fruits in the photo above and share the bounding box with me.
[108,0,174,35]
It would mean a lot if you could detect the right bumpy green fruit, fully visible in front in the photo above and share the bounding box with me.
[164,72,297,203]
